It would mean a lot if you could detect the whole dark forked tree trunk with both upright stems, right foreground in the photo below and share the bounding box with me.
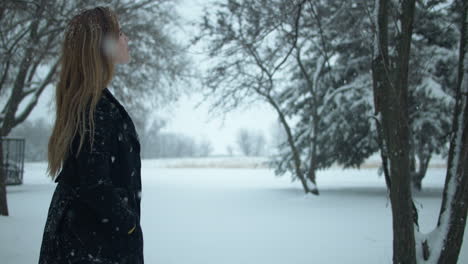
[373,0,416,264]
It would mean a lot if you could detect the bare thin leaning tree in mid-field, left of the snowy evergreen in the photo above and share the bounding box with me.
[200,0,318,194]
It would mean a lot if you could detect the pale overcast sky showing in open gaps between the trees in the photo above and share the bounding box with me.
[28,0,276,154]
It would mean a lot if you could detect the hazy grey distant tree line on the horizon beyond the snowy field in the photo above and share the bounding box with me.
[10,118,278,161]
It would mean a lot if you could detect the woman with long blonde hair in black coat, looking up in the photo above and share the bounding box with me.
[39,7,143,264]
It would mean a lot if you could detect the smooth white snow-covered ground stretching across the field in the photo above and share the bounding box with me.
[0,160,468,264]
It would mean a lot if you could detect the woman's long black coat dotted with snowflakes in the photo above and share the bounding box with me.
[39,88,143,264]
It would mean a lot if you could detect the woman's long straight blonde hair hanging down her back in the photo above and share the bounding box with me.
[48,7,119,178]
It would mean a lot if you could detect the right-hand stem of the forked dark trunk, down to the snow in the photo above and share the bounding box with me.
[392,0,416,264]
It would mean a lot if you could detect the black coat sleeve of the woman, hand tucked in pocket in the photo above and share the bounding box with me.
[72,102,137,235]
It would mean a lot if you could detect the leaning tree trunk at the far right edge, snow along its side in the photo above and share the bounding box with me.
[438,0,468,264]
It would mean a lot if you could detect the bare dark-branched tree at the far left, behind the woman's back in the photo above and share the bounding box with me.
[0,0,67,215]
